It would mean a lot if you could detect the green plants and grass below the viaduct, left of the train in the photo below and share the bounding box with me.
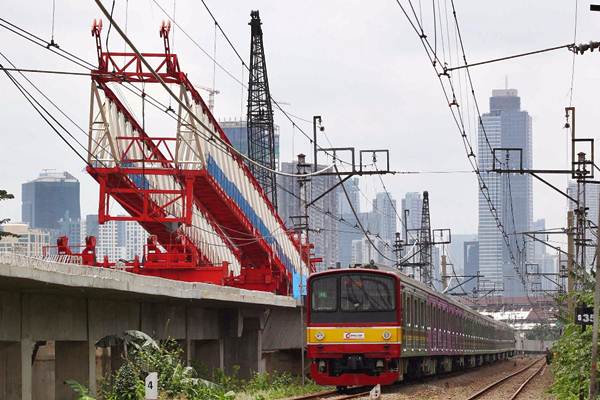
[66,331,324,400]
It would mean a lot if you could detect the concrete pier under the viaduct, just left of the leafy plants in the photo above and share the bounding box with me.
[54,341,96,400]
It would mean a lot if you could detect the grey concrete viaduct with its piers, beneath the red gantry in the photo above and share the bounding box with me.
[0,253,302,400]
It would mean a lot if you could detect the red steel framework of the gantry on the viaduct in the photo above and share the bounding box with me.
[48,20,316,295]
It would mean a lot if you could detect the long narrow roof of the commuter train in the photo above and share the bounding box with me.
[309,265,512,330]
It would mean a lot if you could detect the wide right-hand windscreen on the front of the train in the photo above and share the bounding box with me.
[340,274,396,311]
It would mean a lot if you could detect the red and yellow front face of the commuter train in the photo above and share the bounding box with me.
[306,269,402,386]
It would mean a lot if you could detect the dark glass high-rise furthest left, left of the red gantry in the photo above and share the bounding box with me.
[21,170,81,233]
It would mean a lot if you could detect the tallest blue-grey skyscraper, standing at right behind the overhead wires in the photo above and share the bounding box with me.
[478,89,533,296]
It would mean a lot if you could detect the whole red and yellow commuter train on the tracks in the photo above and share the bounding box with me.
[306,268,515,389]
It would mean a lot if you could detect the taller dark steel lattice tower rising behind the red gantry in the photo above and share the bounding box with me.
[248,11,277,208]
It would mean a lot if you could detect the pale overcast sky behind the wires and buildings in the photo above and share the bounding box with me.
[0,0,600,244]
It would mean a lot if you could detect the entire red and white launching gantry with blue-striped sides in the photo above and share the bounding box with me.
[52,21,314,295]
